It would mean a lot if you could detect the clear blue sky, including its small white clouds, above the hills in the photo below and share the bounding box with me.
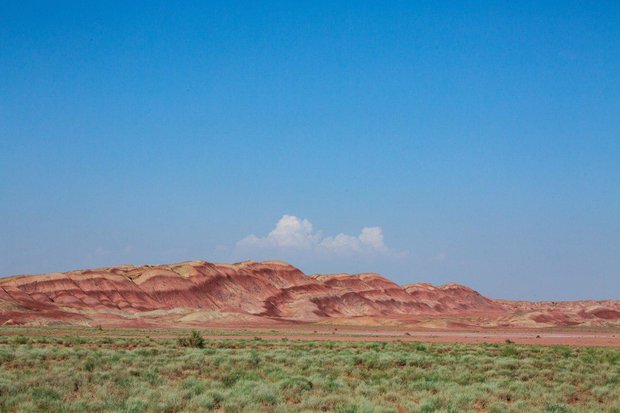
[0,1,620,299]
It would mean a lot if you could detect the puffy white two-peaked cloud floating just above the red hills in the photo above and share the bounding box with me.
[237,215,389,254]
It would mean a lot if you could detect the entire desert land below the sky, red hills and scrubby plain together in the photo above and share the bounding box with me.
[0,261,620,413]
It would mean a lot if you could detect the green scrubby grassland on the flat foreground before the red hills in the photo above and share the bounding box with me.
[0,328,620,413]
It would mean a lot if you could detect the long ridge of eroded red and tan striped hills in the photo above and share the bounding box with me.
[0,261,620,327]
